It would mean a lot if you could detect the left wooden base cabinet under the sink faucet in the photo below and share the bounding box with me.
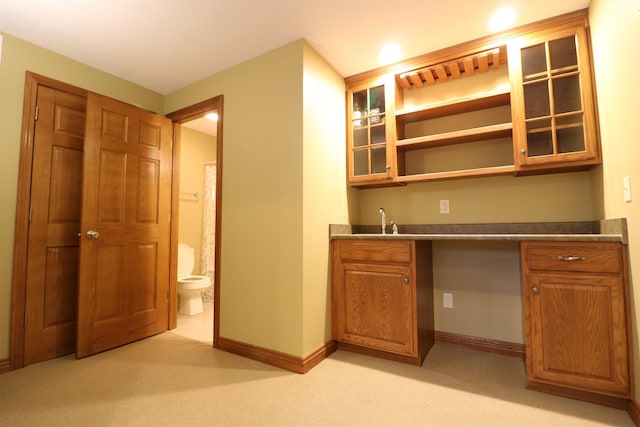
[332,240,433,365]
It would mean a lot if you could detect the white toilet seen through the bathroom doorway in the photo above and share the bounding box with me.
[178,243,211,316]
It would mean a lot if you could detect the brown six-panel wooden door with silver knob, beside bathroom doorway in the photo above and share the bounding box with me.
[76,93,172,357]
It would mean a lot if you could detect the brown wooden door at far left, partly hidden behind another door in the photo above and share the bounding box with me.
[24,85,85,365]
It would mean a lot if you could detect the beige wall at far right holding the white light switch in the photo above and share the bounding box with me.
[589,0,640,404]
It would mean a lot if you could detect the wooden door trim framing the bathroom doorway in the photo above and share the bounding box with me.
[166,95,224,348]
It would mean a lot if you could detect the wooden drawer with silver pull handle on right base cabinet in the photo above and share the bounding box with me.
[523,242,622,273]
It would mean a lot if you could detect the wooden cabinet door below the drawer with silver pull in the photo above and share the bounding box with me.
[524,273,629,396]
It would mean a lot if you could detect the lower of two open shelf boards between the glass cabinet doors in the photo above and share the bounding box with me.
[396,123,513,151]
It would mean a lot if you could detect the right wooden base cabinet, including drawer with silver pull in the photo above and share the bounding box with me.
[521,242,632,406]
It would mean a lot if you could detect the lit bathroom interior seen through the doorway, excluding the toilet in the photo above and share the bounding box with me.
[168,96,222,346]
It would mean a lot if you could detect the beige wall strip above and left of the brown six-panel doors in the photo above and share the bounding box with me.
[0,35,163,360]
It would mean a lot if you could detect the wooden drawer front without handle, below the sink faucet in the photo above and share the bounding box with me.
[336,240,412,263]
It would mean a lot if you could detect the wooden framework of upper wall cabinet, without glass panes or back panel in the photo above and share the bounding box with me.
[345,9,602,188]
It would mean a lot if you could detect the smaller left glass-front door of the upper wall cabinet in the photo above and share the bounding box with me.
[347,79,394,185]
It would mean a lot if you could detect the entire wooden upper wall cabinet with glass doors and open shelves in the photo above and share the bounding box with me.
[345,11,601,187]
